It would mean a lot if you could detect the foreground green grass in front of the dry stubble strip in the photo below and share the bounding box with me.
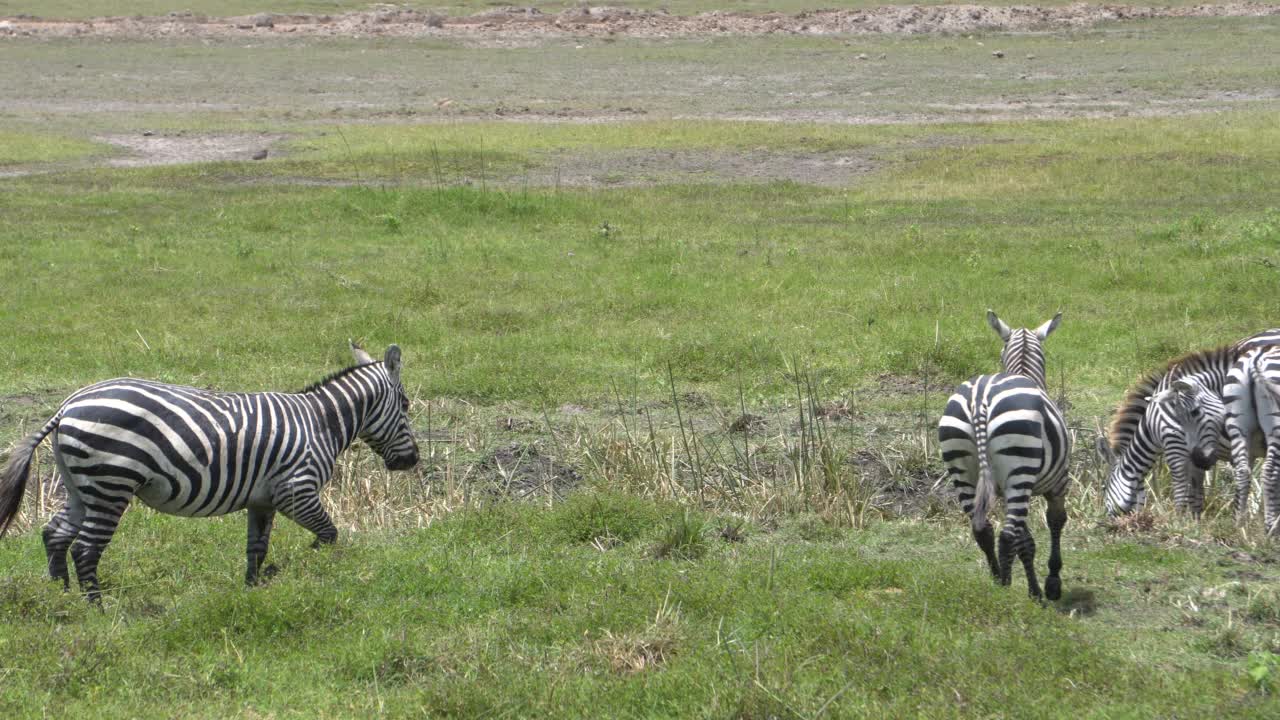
[0,493,1280,717]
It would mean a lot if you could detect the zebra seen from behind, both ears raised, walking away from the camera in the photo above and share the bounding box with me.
[938,311,1071,600]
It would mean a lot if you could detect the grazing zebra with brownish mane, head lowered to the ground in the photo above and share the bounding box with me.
[1098,329,1280,516]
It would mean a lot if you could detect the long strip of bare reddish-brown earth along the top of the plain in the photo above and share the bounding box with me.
[0,3,1280,38]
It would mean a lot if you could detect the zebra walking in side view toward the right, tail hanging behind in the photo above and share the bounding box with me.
[0,343,417,602]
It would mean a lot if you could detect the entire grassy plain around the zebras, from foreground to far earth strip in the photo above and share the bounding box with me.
[0,8,1280,719]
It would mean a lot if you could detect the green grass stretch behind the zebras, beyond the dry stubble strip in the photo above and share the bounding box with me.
[0,114,1280,399]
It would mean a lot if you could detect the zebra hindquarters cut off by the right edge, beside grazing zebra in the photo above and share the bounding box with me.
[1222,346,1280,525]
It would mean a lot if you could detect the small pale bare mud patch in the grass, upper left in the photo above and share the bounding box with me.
[93,132,284,168]
